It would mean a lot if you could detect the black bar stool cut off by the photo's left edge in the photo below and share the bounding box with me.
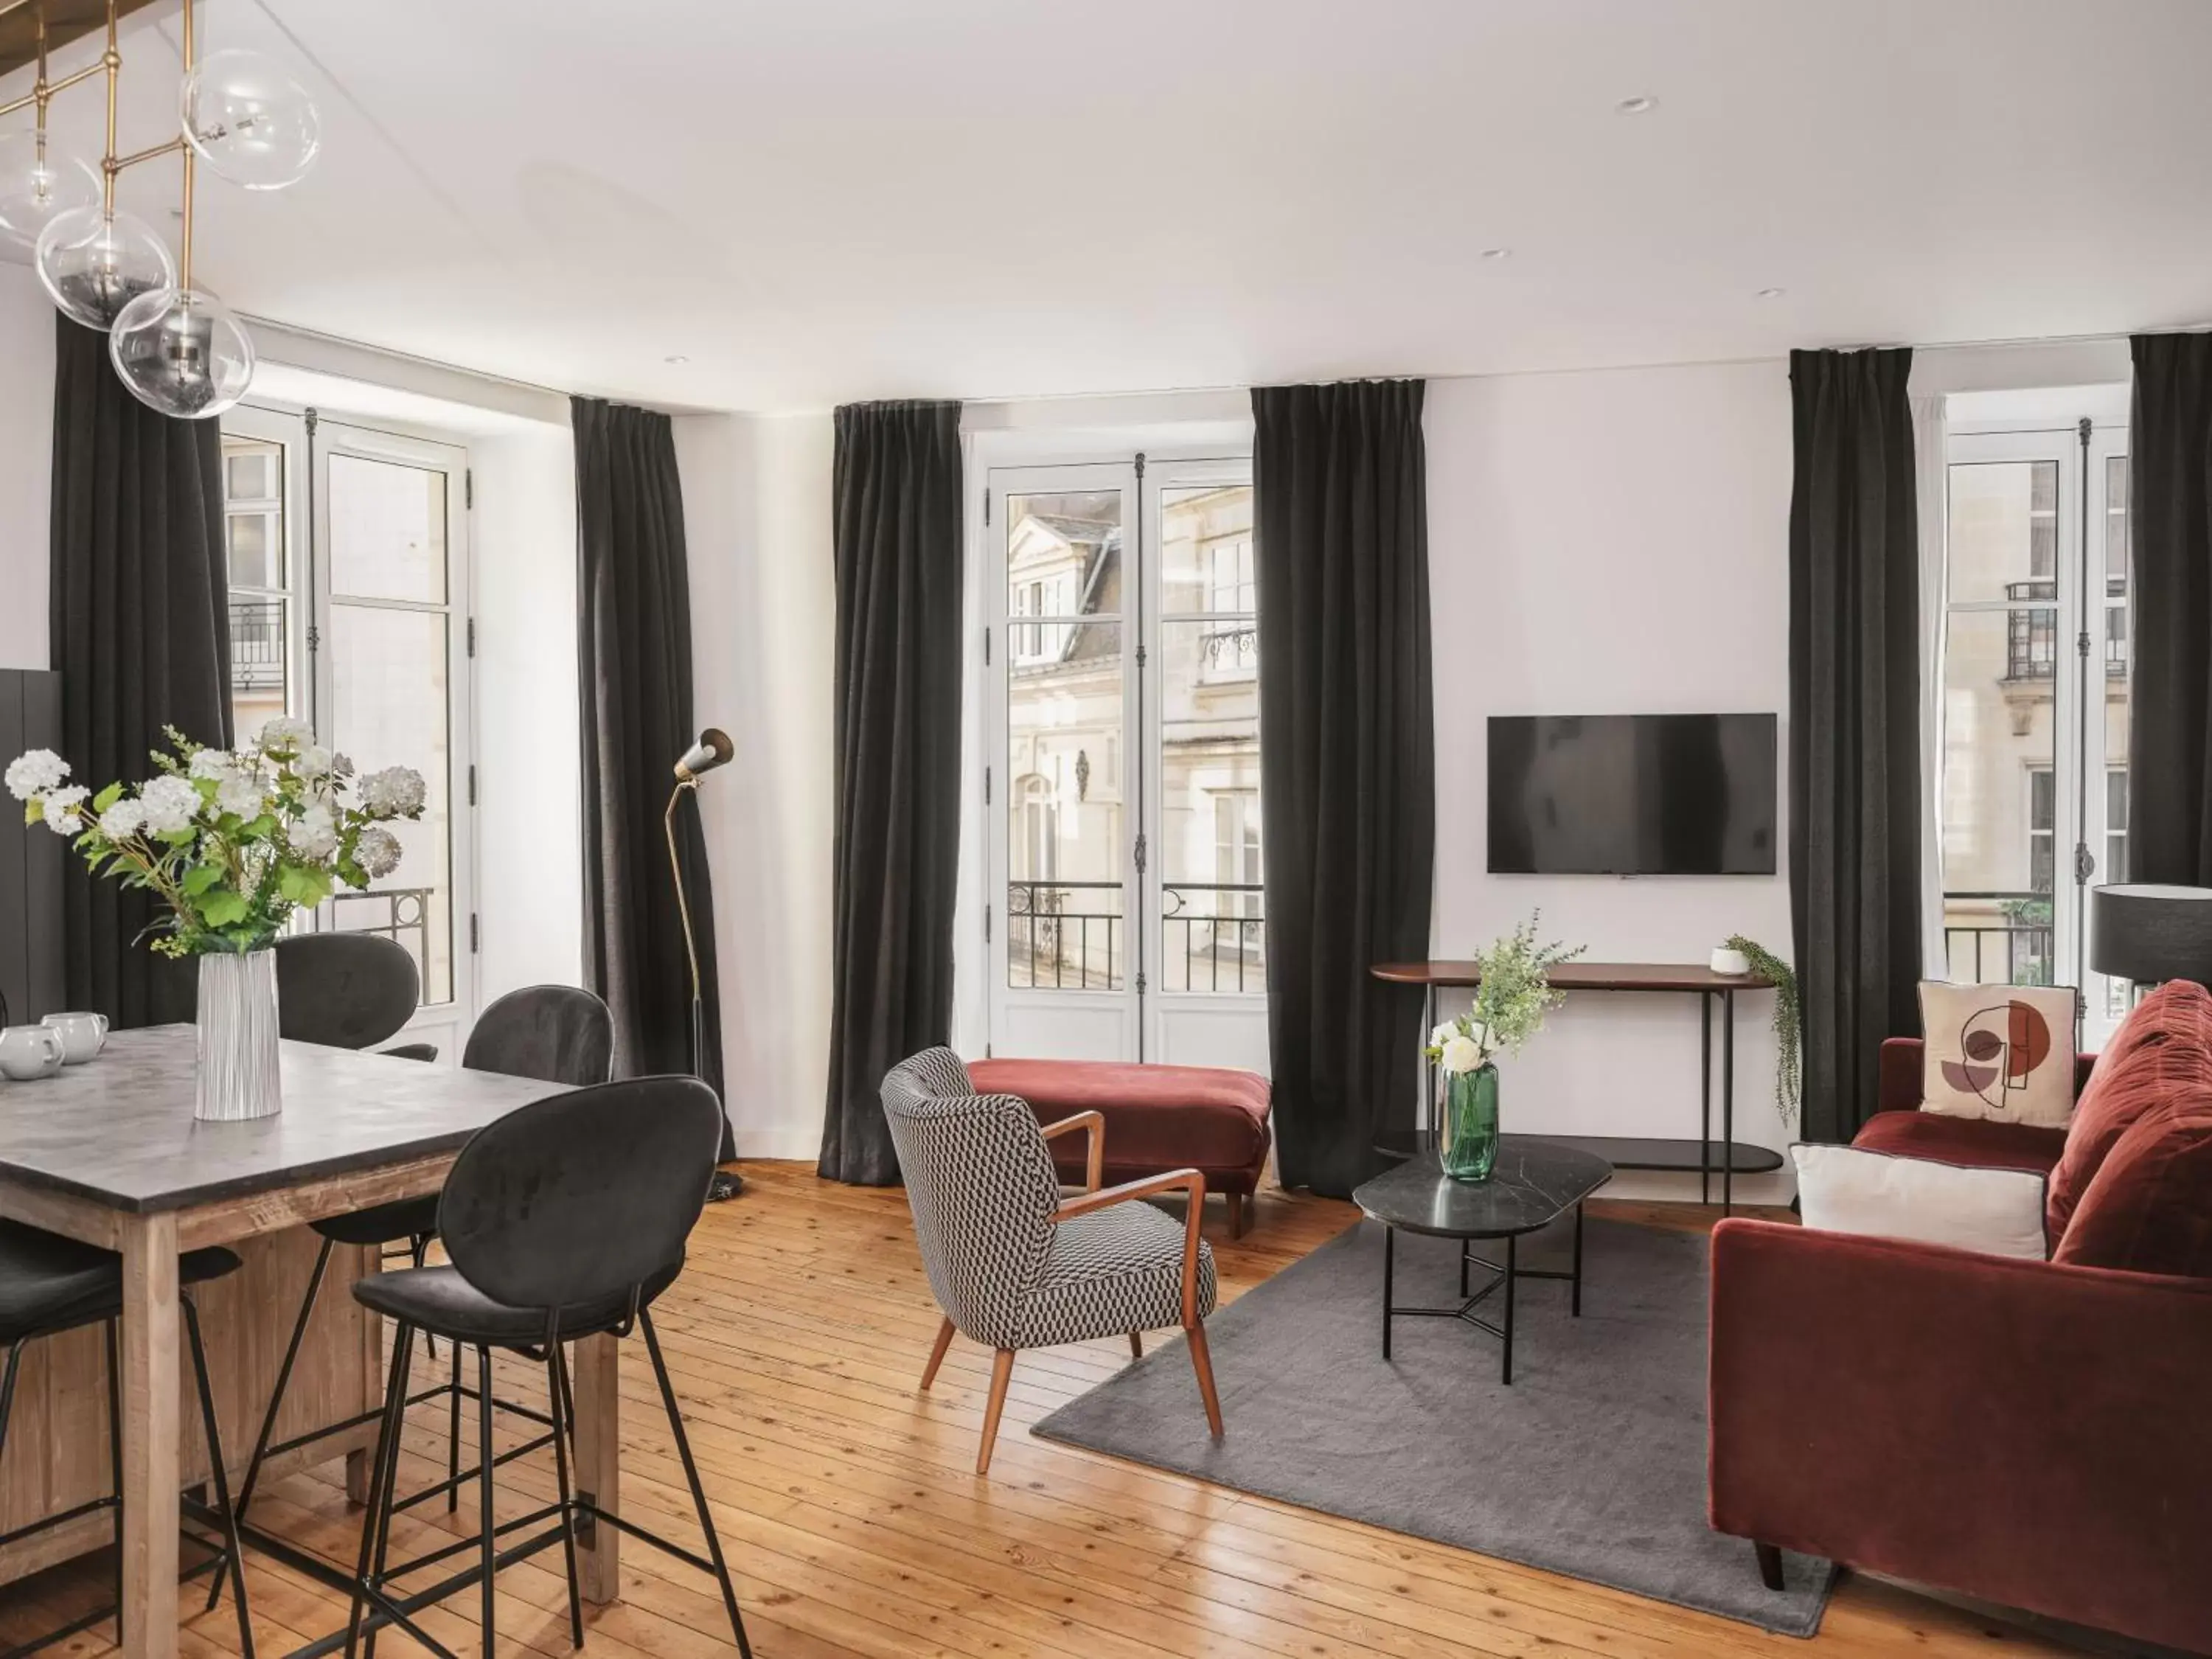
[0,1221,254,1659]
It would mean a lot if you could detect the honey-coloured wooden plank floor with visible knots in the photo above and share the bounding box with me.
[0,1164,2066,1659]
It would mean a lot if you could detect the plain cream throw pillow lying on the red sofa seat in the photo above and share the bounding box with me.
[1790,1144,2051,1261]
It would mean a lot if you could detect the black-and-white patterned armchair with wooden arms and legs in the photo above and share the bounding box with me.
[883,1048,1221,1475]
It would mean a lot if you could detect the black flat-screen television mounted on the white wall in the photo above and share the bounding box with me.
[1491,714,1774,876]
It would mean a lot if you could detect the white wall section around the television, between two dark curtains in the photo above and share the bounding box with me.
[1425,363,1792,1197]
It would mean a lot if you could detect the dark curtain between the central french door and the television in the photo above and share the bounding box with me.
[1252,380,1436,1197]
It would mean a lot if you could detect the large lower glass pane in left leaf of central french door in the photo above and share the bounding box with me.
[1006,619,1130,991]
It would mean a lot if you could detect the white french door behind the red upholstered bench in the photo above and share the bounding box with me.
[982,456,1267,1071]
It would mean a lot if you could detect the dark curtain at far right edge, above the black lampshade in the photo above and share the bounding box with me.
[2106,334,2212,887]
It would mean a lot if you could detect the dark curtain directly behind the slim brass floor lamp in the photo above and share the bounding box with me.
[571,398,732,1159]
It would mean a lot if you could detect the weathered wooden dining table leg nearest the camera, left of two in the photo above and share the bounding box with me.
[122,1214,184,1659]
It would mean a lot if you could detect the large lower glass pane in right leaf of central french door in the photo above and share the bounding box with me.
[1159,619,1267,993]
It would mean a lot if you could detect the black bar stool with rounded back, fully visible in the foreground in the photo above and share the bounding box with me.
[347,1077,752,1659]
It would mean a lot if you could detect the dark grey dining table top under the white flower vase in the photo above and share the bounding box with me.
[0,1026,564,1212]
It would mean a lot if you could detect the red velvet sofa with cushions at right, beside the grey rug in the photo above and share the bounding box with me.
[1708,984,2212,1652]
